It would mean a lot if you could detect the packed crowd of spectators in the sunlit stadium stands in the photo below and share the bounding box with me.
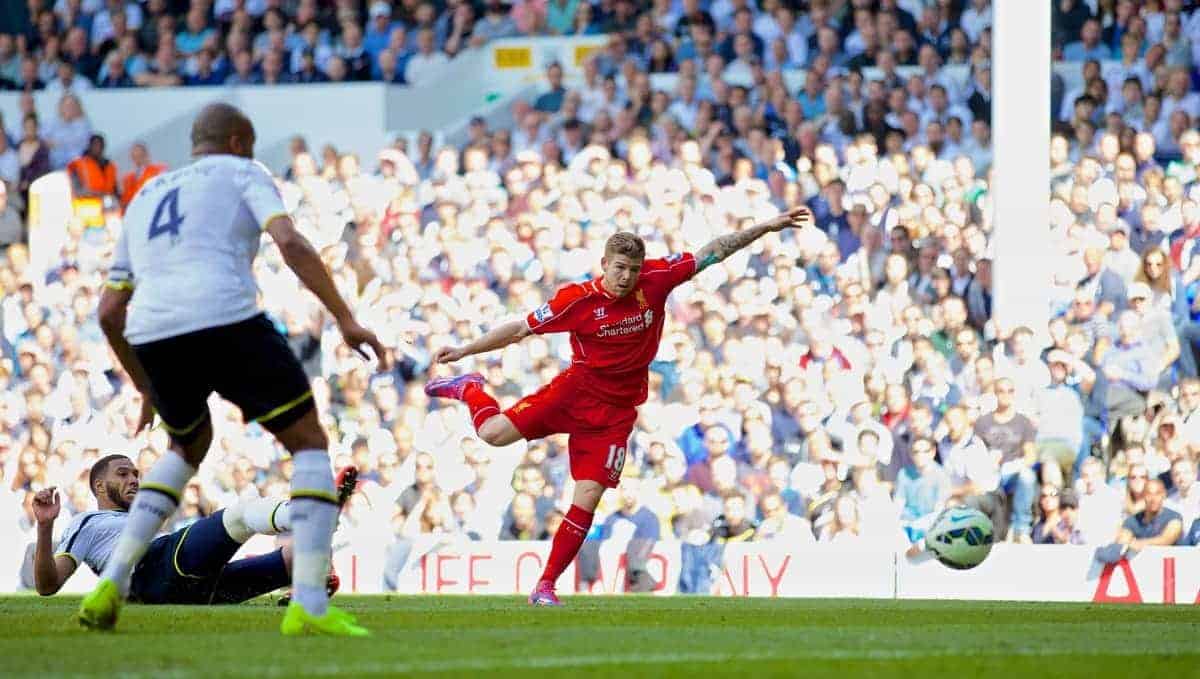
[0,0,1200,591]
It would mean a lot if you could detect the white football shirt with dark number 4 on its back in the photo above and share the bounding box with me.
[108,155,287,344]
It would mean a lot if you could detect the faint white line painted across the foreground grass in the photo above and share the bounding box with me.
[8,647,1200,679]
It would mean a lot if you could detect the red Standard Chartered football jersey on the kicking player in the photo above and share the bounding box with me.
[526,253,696,405]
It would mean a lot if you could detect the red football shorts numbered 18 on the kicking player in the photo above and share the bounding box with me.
[504,371,637,488]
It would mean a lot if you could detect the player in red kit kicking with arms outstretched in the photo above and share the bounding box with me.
[425,208,814,606]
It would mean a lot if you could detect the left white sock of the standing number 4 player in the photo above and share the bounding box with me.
[102,450,196,596]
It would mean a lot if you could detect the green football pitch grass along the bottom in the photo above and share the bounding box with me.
[0,596,1200,679]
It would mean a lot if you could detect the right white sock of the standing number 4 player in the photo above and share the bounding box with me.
[289,450,340,615]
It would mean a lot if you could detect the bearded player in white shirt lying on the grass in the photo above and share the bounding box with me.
[34,455,358,603]
